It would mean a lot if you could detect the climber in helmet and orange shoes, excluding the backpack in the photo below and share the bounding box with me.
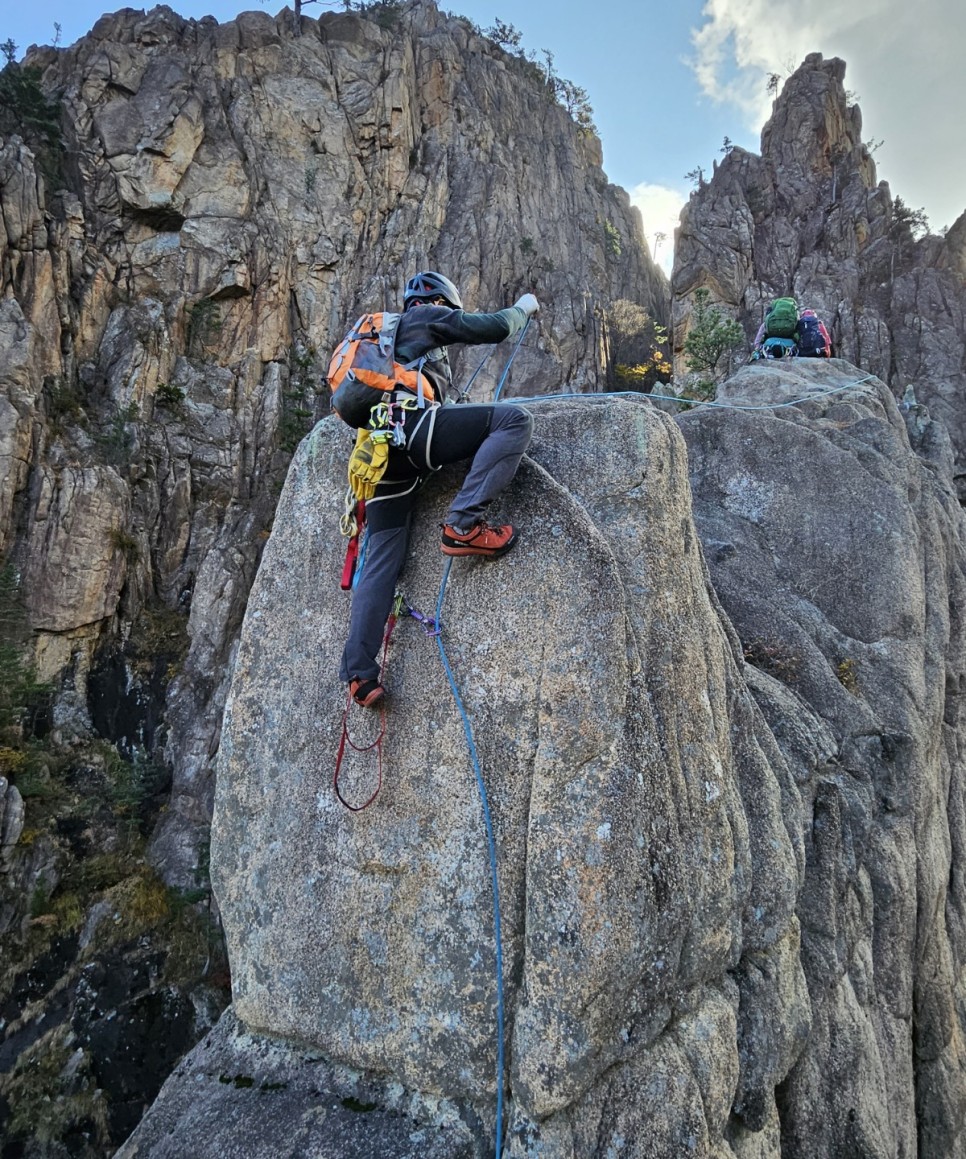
[340,271,539,708]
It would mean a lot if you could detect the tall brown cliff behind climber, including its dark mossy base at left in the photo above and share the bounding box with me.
[0,2,668,1154]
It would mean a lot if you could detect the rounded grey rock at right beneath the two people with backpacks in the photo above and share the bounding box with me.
[681,359,966,1159]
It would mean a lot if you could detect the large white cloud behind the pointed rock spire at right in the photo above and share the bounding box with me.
[690,0,966,228]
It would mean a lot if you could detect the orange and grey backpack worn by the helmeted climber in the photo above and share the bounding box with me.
[326,312,435,428]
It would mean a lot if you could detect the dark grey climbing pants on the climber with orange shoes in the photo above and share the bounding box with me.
[340,403,533,680]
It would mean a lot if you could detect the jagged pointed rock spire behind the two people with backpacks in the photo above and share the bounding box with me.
[671,53,966,497]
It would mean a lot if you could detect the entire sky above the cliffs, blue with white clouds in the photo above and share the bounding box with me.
[0,0,966,273]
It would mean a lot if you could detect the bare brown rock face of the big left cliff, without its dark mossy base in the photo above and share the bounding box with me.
[0,0,667,884]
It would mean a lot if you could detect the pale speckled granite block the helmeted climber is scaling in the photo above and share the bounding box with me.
[131,399,809,1159]
